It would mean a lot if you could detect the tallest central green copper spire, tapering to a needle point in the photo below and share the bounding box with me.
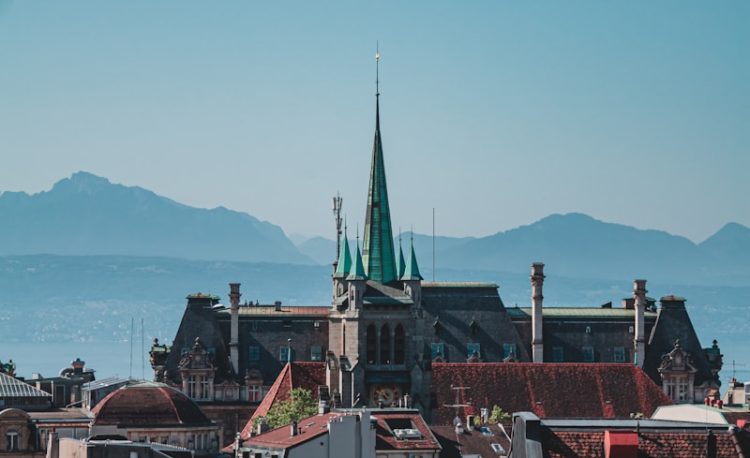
[362,54,398,283]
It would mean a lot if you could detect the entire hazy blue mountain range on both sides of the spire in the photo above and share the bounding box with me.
[0,172,750,286]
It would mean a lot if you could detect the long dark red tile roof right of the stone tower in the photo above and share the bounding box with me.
[432,363,671,425]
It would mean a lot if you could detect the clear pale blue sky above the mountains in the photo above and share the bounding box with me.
[0,0,750,241]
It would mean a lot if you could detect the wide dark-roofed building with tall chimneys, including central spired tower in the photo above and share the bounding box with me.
[151,78,721,432]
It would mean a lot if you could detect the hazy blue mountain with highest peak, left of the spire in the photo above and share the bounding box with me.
[0,172,312,264]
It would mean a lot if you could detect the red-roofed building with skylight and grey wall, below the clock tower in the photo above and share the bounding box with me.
[235,409,441,458]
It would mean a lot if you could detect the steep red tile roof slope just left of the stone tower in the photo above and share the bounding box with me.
[242,361,326,439]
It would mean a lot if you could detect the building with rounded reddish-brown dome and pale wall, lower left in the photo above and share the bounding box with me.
[90,382,221,456]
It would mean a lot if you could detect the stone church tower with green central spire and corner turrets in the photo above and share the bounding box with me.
[326,77,425,407]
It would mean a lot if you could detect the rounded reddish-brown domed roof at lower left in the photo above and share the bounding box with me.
[91,382,213,428]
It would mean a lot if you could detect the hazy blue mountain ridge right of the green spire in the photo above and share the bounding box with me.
[415,213,750,285]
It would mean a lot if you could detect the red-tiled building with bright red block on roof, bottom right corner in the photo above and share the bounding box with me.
[509,412,750,458]
